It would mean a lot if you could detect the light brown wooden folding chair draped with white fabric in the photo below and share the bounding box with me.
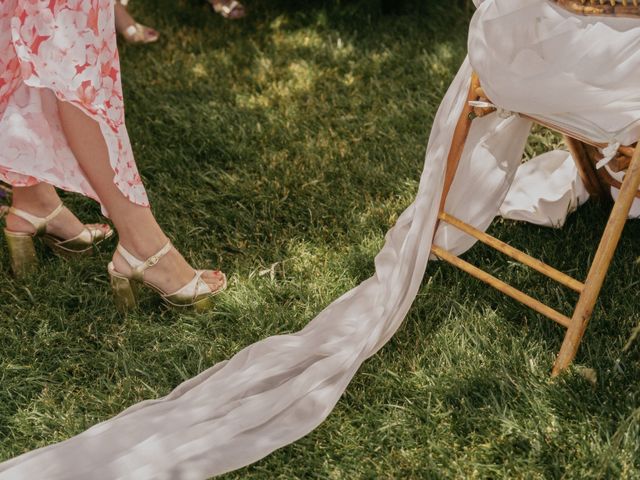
[431,0,640,376]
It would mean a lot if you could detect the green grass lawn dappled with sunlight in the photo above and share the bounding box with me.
[0,0,640,479]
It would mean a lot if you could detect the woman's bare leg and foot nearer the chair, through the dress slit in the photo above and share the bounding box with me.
[58,101,222,292]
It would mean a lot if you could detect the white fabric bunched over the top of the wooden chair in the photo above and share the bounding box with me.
[469,0,640,145]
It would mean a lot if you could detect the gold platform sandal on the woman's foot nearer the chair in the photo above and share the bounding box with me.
[108,242,227,312]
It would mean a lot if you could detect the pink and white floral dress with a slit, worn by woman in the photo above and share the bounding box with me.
[0,0,148,210]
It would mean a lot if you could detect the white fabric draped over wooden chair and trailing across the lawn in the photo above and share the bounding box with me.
[0,0,640,480]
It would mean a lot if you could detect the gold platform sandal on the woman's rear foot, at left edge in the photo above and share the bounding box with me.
[4,203,113,278]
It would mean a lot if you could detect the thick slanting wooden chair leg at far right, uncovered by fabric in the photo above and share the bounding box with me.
[552,144,640,376]
